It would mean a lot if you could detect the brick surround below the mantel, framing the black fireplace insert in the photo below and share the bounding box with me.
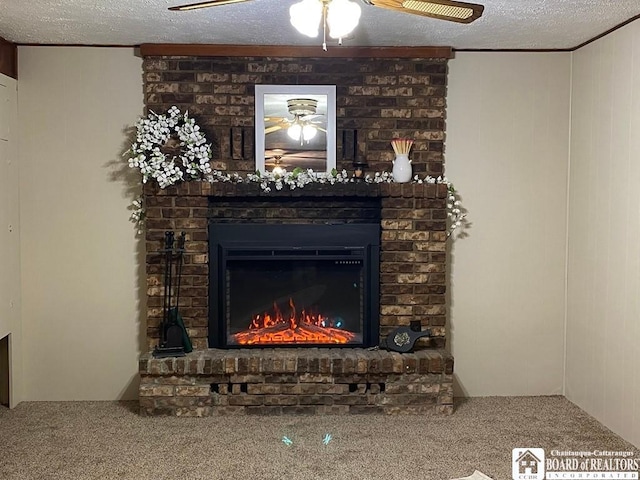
[145,182,447,349]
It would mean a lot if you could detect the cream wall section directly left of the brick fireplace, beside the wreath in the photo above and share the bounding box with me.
[18,47,146,400]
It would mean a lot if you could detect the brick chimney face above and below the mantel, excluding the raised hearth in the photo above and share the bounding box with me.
[144,57,447,349]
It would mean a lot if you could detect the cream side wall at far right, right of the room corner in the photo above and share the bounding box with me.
[566,22,640,445]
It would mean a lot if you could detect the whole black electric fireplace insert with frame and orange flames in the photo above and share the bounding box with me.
[209,223,380,348]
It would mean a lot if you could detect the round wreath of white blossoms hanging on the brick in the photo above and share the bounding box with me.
[125,106,211,188]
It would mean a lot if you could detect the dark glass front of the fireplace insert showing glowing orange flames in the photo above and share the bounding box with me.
[224,252,365,346]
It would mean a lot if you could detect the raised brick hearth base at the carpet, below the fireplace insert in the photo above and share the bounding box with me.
[140,348,453,416]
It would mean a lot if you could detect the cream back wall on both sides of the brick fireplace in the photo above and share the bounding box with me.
[19,47,570,400]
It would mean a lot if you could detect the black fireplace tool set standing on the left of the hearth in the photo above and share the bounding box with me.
[153,232,193,358]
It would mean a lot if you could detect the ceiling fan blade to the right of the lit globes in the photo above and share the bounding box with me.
[362,0,484,23]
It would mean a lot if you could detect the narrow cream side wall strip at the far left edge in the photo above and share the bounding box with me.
[0,74,23,407]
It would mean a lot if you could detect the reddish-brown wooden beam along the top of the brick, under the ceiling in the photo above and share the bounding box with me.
[140,43,453,59]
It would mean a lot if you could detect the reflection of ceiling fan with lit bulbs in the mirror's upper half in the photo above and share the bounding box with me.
[264,98,327,145]
